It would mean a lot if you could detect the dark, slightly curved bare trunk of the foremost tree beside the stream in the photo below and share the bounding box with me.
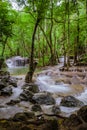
[25,18,40,83]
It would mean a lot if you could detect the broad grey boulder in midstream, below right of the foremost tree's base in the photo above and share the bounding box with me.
[32,93,55,105]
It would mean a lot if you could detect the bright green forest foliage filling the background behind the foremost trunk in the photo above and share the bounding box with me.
[0,0,87,66]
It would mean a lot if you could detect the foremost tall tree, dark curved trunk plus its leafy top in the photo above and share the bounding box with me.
[25,0,48,83]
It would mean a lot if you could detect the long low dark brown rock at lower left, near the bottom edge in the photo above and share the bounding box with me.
[12,112,35,121]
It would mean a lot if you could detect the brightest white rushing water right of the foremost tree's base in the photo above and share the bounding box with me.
[37,75,72,93]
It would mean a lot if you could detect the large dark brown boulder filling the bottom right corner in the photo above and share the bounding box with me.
[62,105,87,130]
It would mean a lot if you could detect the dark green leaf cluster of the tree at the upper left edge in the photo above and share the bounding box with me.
[0,1,14,42]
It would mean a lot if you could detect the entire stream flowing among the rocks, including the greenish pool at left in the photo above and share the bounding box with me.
[0,62,87,118]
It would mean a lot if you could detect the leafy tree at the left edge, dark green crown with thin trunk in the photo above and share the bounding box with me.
[0,1,14,69]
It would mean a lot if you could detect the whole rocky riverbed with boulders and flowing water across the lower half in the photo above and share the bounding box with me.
[0,66,87,130]
